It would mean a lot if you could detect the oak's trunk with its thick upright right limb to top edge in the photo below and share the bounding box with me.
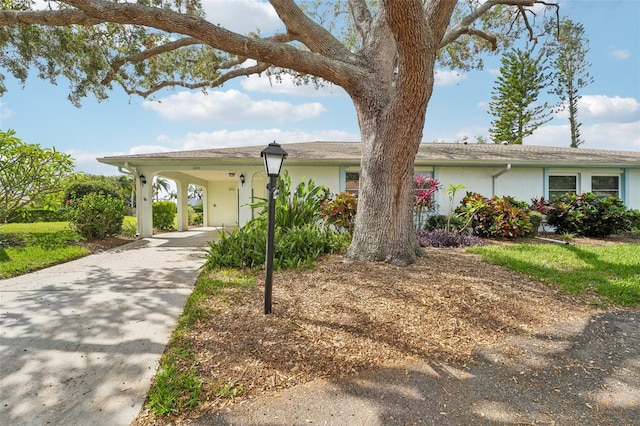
[347,1,455,266]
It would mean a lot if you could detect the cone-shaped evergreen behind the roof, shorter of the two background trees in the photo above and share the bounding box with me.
[489,47,551,145]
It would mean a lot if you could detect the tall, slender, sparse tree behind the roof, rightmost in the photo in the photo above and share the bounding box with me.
[550,19,593,148]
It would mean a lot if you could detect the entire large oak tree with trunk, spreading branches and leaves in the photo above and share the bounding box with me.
[0,0,550,265]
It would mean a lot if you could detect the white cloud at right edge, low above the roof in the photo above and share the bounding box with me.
[557,95,640,123]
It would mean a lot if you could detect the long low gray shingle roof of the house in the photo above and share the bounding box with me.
[98,142,640,168]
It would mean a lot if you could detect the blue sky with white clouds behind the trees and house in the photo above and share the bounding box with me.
[0,0,640,174]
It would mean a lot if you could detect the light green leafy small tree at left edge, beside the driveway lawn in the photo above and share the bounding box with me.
[0,130,73,223]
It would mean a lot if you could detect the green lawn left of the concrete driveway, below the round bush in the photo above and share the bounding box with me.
[0,222,89,279]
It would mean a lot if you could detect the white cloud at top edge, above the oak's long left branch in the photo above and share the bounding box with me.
[202,0,284,35]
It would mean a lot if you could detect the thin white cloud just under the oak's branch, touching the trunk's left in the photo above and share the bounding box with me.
[240,75,346,97]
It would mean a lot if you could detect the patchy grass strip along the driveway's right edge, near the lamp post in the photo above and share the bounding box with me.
[147,269,255,416]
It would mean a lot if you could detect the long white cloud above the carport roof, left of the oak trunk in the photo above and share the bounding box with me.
[142,90,326,124]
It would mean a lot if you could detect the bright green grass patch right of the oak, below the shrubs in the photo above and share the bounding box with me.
[467,244,640,306]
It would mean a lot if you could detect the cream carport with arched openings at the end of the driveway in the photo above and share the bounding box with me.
[98,147,267,238]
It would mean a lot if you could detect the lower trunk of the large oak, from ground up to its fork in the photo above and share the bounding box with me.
[347,67,433,266]
